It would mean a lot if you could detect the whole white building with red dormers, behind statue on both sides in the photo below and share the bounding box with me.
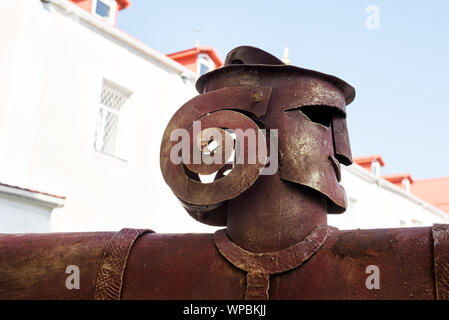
[0,0,447,233]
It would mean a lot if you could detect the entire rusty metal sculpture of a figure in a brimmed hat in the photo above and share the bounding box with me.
[0,47,449,299]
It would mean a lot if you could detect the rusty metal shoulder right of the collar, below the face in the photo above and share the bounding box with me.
[288,225,449,299]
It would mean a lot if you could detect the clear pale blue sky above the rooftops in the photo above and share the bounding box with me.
[118,0,449,179]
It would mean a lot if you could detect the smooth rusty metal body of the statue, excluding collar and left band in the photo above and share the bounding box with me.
[0,226,440,299]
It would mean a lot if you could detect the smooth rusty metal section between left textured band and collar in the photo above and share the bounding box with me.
[122,233,245,299]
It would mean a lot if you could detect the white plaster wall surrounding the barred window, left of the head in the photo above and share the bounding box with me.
[12,1,219,232]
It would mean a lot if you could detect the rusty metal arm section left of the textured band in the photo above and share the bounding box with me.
[0,232,115,299]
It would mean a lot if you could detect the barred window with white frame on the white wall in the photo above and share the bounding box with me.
[94,80,131,160]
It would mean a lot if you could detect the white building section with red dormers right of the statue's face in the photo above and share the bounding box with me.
[328,160,449,229]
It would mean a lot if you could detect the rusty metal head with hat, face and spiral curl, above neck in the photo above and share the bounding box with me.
[160,46,355,238]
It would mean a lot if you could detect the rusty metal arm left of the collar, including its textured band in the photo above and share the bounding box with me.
[0,229,244,299]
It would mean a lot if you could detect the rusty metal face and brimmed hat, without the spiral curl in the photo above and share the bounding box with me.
[197,47,355,213]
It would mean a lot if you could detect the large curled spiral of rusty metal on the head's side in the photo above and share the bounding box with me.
[160,86,271,225]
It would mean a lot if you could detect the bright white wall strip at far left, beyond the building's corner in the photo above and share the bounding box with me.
[0,0,50,185]
